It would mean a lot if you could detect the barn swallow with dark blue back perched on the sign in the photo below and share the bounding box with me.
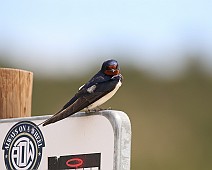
[39,60,123,126]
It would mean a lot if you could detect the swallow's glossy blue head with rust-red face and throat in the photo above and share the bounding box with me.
[101,60,120,76]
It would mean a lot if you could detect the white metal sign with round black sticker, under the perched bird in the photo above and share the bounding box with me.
[0,110,131,170]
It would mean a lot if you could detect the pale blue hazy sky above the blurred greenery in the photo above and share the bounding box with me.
[0,0,212,75]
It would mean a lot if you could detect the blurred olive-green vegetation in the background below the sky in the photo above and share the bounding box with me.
[1,56,212,170]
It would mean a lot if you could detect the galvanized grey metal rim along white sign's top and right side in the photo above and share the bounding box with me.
[0,110,131,170]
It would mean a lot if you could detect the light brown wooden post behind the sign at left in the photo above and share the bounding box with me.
[0,68,33,119]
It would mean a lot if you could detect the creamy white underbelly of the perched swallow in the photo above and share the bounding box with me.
[87,81,121,110]
